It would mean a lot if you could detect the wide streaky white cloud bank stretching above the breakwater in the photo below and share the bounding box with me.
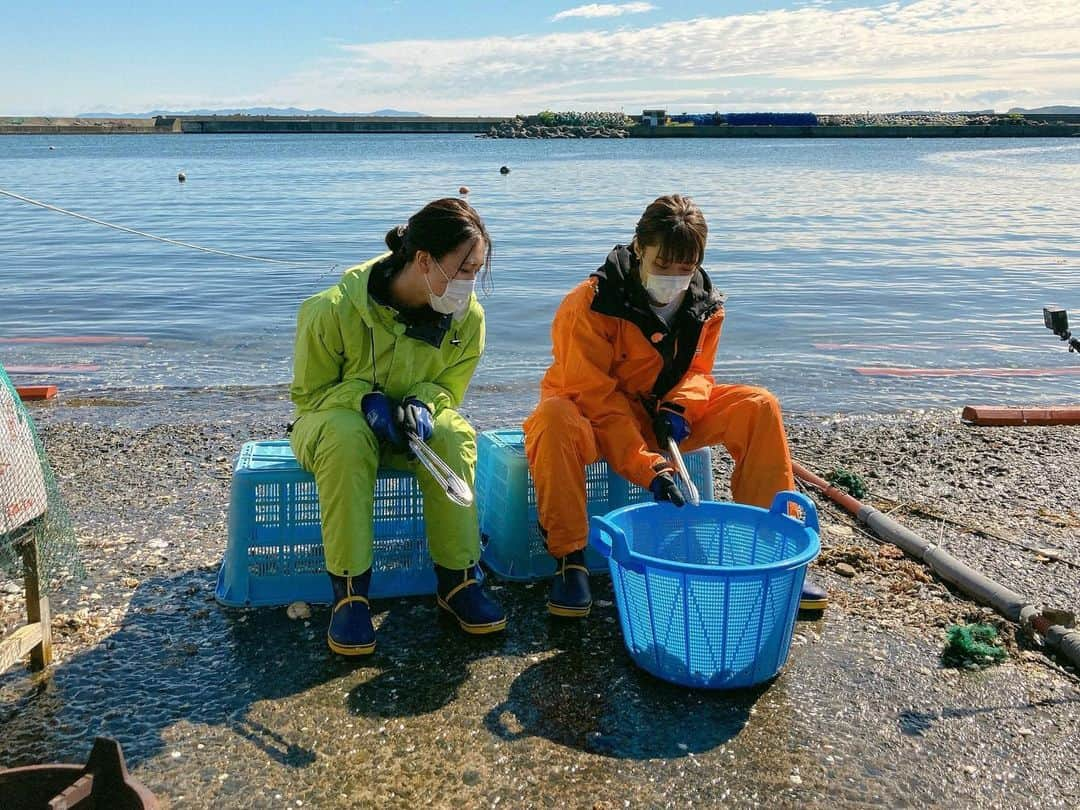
[92,0,1080,114]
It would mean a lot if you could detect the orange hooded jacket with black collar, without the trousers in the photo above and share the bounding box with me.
[540,245,724,486]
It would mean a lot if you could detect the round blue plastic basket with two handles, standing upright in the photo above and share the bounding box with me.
[589,492,821,689]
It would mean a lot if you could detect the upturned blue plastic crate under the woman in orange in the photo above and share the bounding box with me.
[476,430,713,581]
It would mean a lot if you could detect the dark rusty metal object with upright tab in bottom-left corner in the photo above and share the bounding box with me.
[0,737,159,810]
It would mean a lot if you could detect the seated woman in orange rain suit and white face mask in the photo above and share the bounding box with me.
[524,194,827,618]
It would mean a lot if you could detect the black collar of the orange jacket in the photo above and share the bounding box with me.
[592,245,725,336]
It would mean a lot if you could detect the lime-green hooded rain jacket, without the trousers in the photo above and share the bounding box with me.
[289,254,485,416]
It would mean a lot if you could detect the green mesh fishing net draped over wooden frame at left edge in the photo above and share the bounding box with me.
[0,365,84,591]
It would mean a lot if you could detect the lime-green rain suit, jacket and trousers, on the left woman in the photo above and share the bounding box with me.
[289,256,484,577]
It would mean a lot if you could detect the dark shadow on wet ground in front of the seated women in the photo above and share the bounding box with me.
[0,569,764,768]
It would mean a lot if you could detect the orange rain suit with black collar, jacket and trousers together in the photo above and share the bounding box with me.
[524,245,795,557]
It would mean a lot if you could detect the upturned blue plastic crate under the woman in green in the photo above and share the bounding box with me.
[215,441,435,607]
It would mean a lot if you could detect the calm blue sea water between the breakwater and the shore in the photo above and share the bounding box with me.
[0,135,1080,418]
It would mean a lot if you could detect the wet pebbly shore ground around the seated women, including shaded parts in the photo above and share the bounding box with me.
[0,392,1080,808]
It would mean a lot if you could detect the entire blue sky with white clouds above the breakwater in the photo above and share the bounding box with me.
[0,0,1080,116]
